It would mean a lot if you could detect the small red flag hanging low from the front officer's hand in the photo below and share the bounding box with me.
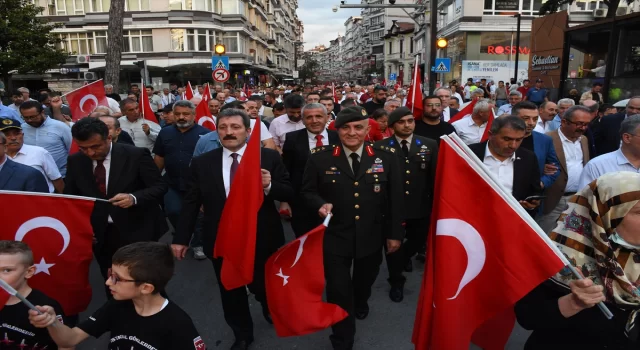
[265,220,347,337]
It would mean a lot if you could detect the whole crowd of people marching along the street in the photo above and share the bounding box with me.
[0,80,640,349]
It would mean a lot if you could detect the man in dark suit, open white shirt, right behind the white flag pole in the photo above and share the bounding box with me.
[469,116,542,216]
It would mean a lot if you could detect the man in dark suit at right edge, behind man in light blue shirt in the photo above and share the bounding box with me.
[591,96,640,158]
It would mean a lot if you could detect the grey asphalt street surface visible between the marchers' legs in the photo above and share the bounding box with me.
[77,223,528,350]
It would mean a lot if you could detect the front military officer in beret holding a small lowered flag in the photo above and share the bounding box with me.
[301,106,404,349]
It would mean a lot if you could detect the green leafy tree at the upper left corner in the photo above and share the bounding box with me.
[0,0,68,91]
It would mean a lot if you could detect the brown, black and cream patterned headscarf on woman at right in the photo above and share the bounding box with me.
[550,172,640,308]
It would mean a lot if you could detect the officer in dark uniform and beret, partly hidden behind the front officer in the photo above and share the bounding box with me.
[374,107,438,303]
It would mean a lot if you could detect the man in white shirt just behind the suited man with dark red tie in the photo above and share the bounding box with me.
[118,98,161,151]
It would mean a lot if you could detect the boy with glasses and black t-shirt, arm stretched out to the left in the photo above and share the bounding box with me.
[29,242,206,350]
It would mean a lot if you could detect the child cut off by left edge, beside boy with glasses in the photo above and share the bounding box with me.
[0,241,69,350]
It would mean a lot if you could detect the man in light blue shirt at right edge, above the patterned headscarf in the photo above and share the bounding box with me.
[578,114,640,189]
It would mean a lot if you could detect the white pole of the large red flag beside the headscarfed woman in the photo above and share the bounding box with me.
[441,133,613,319]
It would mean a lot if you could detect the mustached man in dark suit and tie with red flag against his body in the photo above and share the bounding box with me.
[171,108,294,350]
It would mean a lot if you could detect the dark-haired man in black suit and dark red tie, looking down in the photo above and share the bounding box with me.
[64,118,169,286]
